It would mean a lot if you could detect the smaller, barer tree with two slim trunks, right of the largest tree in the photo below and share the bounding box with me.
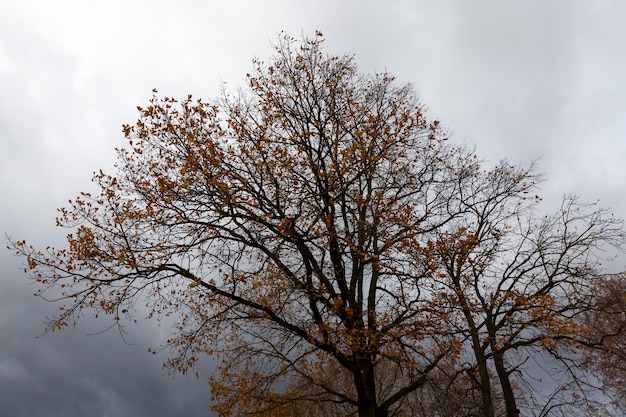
[422,187,624,417]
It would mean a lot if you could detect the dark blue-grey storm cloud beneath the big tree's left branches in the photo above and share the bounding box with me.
[0,254,210,417]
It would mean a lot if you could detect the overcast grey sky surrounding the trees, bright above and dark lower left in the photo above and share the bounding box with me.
[0,0,626,417]
